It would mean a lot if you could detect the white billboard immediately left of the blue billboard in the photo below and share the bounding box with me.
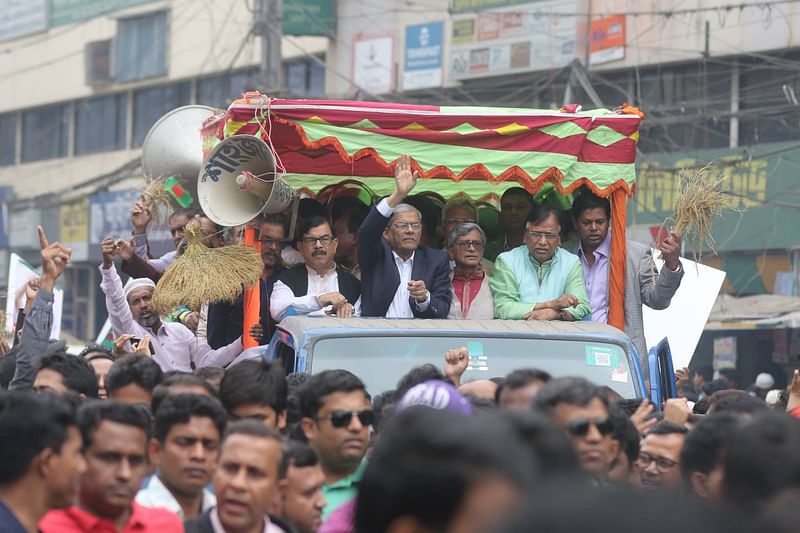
[353,35,394,94]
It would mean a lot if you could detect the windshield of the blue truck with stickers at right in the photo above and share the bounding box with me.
[311,333,640,398]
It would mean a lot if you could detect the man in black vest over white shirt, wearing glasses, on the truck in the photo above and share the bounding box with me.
[269,216,361,322]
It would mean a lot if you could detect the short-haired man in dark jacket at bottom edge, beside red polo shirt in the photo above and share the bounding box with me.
[185,420,289,533]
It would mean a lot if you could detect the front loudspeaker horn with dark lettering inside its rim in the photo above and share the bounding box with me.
[197,135,294,226]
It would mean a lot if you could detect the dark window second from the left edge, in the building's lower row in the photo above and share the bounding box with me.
[22,104,69,163]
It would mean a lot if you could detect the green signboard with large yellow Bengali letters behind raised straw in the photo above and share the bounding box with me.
[628,142,800,252]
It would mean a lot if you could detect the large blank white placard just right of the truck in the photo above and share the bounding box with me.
[643,250,725,368]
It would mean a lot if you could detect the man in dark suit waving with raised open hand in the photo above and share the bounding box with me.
[358,155,451,318]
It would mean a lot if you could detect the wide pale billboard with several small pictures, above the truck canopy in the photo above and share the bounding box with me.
[449,0,577,80]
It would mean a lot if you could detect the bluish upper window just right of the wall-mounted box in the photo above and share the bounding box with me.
[114,11,167,83]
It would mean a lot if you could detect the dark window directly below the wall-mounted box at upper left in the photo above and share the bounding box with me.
[75,94,128,155]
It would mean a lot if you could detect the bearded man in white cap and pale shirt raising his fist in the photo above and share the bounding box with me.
[100,237,242,372]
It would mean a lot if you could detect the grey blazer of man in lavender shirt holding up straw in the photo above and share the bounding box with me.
[564,239,683,368]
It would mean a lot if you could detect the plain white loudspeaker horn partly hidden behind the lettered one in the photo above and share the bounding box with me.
[141,105,215,200]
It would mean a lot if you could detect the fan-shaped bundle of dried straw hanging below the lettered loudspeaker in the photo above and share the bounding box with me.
[153,223,264,313]
